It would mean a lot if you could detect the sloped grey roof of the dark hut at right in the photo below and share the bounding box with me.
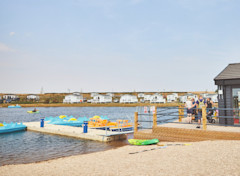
[214,63,240,80]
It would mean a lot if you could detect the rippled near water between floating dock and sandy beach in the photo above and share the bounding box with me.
[0,131,129,166]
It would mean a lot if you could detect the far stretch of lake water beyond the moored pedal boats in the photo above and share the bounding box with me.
[0,107,136,123]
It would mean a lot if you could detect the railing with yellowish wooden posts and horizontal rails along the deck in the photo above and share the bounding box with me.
[134,106,240,132]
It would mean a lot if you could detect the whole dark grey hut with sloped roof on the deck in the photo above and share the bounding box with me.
[214,63,240,125]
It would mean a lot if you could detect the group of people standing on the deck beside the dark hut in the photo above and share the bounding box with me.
[185,95,213,128]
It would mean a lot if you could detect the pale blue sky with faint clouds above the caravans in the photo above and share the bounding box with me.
[0,0,240,93]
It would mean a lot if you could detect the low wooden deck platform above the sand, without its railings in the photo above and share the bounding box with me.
[134,123,240,142]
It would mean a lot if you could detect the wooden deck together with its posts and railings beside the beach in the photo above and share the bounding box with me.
[134,106,240,142]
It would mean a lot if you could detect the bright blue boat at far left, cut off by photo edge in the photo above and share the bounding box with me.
[0,123,27,134]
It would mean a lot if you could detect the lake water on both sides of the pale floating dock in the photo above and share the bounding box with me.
[0,107,136,166]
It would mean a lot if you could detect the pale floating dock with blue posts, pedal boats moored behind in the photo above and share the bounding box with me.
[24,122,131,142]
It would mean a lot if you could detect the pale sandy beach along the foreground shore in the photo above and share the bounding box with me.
[0,141,240,176]
